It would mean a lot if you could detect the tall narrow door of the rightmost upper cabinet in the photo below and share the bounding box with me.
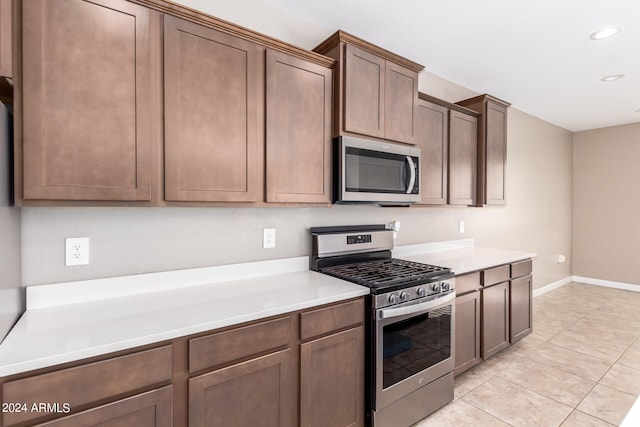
[485,102,507,205]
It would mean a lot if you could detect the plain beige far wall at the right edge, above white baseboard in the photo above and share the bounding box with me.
[573,123,640,287]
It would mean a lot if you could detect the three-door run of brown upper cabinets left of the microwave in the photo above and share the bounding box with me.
[15,0,335,206]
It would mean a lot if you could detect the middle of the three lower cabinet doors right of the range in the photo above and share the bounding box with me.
[481,281,509,360]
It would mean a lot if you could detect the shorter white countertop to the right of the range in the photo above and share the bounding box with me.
[393,239,537,275]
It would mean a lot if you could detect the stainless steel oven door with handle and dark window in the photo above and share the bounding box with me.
[373,291,455,410]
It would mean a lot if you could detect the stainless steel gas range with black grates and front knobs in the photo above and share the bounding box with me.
[310,225,455,427]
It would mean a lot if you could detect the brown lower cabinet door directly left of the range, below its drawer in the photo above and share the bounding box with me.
[300,326,364,427]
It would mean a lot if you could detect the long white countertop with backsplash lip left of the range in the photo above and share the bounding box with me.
[0,257,369,377]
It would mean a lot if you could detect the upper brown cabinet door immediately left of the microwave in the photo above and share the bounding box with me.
[266,50,332,203]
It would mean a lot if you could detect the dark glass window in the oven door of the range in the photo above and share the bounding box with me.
[382,305,451,389]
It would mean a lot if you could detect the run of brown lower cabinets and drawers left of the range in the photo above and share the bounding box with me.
[0,298,365,427]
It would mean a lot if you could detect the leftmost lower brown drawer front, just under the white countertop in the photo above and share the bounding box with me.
[2,345,173,427]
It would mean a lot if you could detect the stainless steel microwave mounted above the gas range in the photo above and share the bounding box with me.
[334,136,420,205]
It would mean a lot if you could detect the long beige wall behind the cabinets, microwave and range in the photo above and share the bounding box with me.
[22,0,572,287]
